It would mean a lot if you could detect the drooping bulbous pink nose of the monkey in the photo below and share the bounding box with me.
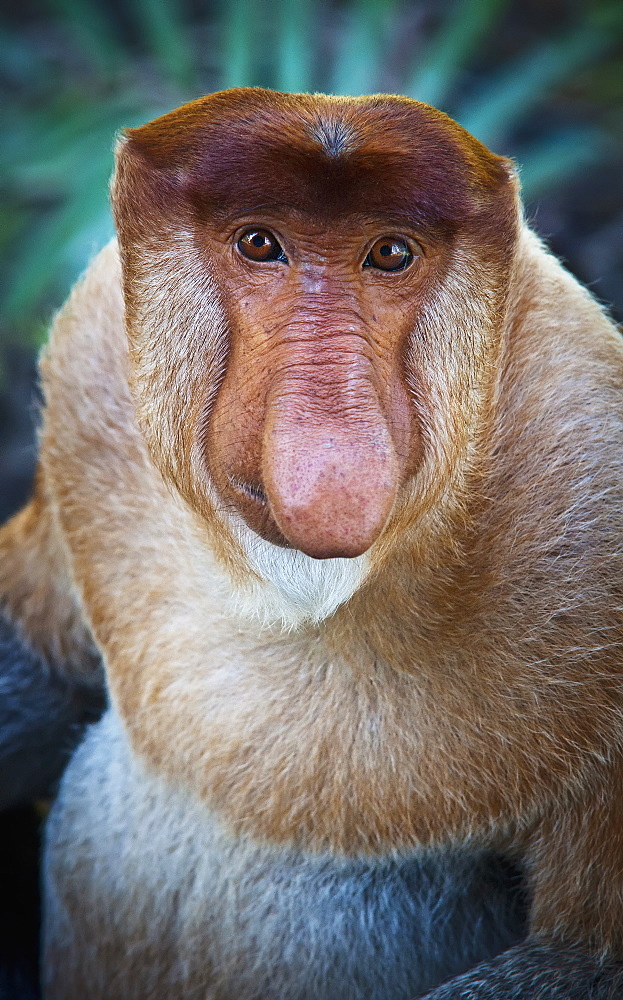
[262,384,399,559]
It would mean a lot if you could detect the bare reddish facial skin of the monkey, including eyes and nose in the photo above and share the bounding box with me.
[200,212,426,557]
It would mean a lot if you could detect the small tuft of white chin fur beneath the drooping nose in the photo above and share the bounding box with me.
[228,517,368,629]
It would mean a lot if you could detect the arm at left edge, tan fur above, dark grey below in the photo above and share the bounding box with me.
[0,474,104,809]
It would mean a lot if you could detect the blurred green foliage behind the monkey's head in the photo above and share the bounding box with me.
[0,0,623,354]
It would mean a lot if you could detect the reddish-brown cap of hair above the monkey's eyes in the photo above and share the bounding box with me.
[117,89,510,233]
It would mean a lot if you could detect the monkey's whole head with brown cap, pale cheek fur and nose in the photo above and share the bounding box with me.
[115,90,517,572]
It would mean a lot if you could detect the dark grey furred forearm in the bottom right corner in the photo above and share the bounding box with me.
[424,943,623,1000]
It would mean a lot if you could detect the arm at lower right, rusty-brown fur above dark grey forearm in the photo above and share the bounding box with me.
[426,755,623,1000]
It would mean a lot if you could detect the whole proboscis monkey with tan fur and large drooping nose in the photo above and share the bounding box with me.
[0,90,623,1000]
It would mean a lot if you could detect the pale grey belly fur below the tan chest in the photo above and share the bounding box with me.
[46,714,525,1000]
